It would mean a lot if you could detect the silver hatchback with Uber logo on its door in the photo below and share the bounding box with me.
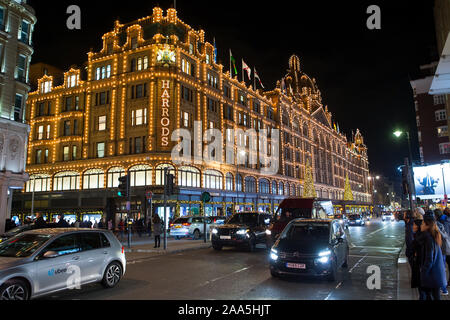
[0,229,126,300]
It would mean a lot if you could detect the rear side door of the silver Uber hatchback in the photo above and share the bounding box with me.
[79,232,110,283]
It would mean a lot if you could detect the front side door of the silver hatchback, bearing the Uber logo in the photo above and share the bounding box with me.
[35,234,81,294]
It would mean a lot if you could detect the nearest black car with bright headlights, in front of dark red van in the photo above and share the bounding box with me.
[270,219,349,281]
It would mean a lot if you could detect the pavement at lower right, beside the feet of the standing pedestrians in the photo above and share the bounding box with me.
[397,245,450,301]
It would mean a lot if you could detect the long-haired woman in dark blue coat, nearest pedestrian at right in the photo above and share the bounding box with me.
[419,211,447,300]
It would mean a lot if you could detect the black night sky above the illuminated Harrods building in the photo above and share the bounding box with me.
[29,0,437,178]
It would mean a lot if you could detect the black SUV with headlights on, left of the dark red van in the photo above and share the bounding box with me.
[211,212,272,251]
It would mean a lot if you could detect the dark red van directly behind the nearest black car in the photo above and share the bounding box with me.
[267,198,334,248]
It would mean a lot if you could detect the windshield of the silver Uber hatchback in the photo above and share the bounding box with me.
[0,234,52,258]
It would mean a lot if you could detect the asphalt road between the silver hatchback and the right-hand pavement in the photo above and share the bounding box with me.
[39,220,404,300]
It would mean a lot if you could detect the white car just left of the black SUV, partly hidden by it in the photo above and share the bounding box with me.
[169,216,220,240]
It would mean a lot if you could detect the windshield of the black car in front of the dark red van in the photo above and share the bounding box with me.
[280,223,330,241]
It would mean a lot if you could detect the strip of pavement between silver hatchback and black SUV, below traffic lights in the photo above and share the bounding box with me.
[122,237,211,262]
